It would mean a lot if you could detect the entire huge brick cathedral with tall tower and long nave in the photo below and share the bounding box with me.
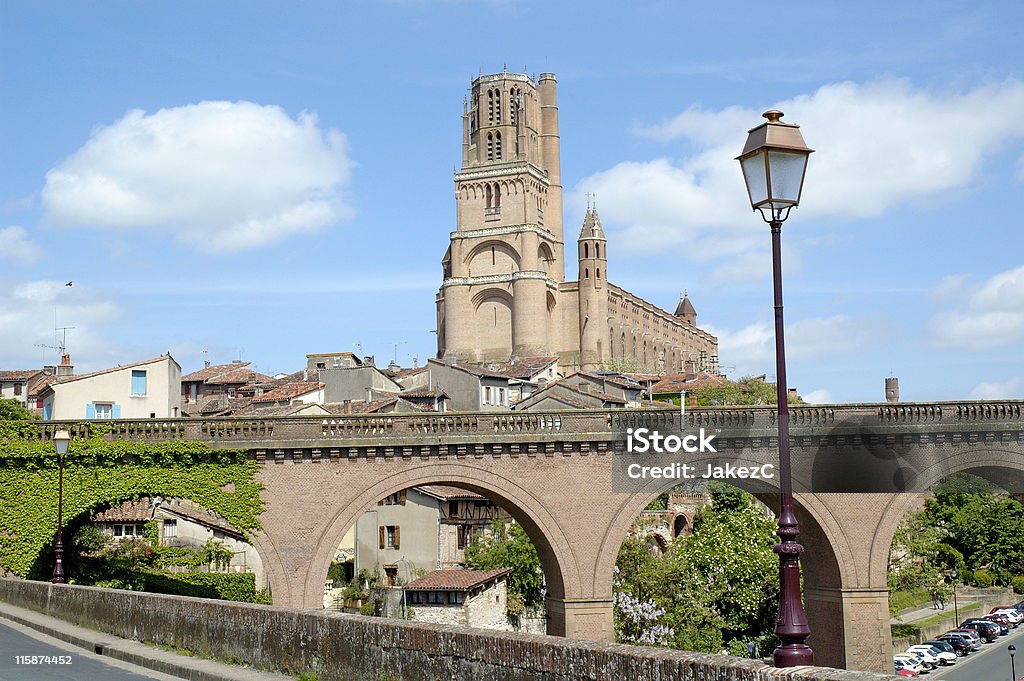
[437,73,718,374]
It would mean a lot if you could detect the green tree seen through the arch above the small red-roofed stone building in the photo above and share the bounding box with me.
[466,520,544,614]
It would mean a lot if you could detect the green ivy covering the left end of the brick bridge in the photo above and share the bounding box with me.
[0,421,263,578]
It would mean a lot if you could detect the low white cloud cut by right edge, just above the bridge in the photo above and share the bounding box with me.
[930,265,1024,348]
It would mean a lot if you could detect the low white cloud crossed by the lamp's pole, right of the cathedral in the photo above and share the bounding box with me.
[708,314,877,376]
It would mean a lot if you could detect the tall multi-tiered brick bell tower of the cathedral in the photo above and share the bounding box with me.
[436,72,565,361]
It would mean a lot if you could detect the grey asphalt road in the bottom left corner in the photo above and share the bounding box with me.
[0,619,180,681]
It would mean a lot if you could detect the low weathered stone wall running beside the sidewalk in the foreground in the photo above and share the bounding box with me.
[0,580,897,681]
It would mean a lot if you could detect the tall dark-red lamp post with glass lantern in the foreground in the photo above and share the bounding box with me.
[736,111,814,667]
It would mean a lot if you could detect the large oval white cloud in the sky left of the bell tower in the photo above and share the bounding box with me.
[42,101,352,252]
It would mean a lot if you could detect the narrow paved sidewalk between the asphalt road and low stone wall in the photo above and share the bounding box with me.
[0,602,295,681]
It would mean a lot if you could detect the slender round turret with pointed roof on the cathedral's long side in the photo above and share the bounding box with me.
[578,208,611,371]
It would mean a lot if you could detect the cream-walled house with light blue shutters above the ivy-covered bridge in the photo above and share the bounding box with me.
[40,354,181,420]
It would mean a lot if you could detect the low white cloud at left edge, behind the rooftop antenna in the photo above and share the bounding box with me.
[0,280,123,372]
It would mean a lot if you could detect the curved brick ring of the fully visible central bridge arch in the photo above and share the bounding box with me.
[301,462,583,614]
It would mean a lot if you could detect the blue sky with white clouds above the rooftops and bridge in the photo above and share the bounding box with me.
[0,0,1024,402]
